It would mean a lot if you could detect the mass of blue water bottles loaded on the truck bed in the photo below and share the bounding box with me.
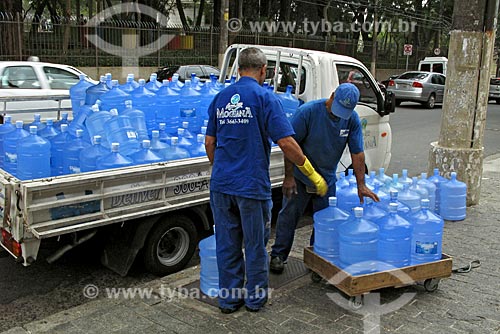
[0,73,298,180]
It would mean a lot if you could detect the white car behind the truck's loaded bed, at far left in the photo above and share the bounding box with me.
[0,61,94,121]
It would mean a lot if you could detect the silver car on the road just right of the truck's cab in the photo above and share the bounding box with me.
[387,71,446,109]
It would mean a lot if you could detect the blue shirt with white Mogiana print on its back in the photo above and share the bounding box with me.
[207,77,294,200]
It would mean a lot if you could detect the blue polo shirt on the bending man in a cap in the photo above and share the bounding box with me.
[291,99,363,187]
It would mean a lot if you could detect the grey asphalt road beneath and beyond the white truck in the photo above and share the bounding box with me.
[0,103,500,332]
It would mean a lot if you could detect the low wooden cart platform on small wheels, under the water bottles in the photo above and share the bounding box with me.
[304,247,452,297]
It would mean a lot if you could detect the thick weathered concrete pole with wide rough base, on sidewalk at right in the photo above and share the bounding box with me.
[429,0,499,205]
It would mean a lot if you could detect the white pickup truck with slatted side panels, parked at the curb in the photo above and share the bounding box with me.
[0,45,394,275]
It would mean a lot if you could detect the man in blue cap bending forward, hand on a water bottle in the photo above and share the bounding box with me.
[270,83,379,274]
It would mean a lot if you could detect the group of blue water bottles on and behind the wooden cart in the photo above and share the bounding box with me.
[313,168,467,275]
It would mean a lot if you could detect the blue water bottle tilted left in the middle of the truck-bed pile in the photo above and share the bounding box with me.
[104,109,141,155]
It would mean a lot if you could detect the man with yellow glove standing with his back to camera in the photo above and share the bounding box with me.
[205,47,328,313]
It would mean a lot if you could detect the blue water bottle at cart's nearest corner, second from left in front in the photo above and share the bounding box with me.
[339,207,379,276]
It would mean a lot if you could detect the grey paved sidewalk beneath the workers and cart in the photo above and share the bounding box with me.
[3,155,500,334]
